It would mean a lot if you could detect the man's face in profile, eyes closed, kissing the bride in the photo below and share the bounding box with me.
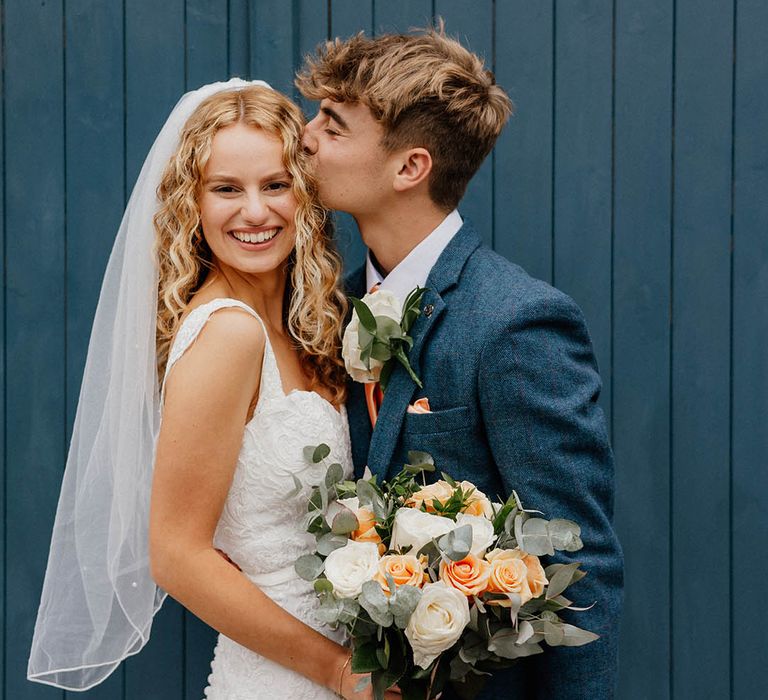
[304,99,393,217]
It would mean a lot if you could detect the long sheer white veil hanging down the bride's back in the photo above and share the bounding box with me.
[27,78,268,690]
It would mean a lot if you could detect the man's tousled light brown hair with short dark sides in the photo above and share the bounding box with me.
[296,20,512,211]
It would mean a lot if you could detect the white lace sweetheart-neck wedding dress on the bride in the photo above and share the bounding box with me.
[166,299,352,700]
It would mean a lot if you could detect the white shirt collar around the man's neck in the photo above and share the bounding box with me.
[365,209,464,303]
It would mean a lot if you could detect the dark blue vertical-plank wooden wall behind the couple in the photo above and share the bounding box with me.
[0,0,768,700]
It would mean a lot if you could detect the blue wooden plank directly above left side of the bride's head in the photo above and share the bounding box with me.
[186,0,228,90]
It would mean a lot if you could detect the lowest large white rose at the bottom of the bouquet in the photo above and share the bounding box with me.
[405,582,469,668]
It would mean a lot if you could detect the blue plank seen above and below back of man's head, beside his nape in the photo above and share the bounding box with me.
[435,0,494,246]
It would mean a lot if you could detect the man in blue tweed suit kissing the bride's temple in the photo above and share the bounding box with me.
[297,24,622,700]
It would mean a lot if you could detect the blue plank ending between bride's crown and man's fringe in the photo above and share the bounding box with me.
[249,0,298,95]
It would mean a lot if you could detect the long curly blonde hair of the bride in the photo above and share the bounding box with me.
[154,86,347,403]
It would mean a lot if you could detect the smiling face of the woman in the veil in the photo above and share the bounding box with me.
[199,123,297,275]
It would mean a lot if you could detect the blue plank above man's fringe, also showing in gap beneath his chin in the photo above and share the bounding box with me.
[329,0,373,271]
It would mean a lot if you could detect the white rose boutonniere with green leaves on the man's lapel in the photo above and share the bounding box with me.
[341,287,427,391]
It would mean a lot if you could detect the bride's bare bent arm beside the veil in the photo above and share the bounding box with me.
[150,310,380,697]
